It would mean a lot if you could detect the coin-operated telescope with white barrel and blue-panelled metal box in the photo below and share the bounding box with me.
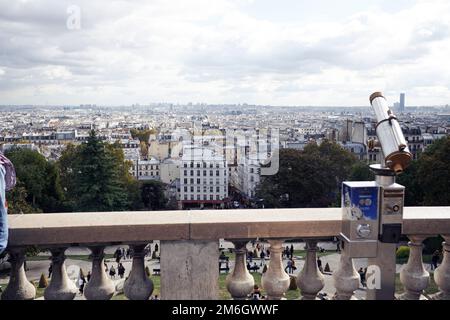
[341,92,412,258]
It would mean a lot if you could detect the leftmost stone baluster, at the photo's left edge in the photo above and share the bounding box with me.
[2,248,36,300]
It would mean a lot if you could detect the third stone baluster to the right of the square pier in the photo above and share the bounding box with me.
[297,240,325,300]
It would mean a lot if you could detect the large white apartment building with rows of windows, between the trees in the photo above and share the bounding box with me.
[179,145,228,208]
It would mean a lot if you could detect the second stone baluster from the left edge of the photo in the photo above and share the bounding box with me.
[44,248,78,300]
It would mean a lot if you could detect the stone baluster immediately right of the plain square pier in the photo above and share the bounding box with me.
[226,241,255,300]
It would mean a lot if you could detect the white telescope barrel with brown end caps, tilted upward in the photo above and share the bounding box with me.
[370,92,412,174]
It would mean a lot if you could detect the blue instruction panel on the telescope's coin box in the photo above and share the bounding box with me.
[342,181,379,220]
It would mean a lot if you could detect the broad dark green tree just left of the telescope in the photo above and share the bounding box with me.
[257,140,356,208]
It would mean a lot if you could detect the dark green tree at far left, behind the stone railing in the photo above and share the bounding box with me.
[6,148,63,212]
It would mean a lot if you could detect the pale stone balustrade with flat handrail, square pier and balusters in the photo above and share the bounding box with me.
[1,207,450,300]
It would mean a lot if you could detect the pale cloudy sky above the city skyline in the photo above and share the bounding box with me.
[0,0,450,106]
